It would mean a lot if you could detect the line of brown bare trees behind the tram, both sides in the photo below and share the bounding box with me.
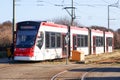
[0,19,120,51]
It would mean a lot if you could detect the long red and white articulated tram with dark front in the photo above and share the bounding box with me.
[14,21,113,61]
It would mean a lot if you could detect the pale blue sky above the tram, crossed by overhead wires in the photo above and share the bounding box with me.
[0,0,120,30]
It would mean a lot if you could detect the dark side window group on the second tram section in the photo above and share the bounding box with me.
[77,35,88,47]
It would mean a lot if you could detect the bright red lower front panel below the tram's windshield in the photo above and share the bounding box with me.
[14,48,34,57]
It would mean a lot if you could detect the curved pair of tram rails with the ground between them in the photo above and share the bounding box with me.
[51,67,94,80]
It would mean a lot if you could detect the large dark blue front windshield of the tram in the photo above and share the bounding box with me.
[16,30,37,48]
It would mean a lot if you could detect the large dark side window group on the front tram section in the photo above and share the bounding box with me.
[45,32,61,48]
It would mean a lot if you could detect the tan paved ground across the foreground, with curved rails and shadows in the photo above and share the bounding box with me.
[0,59,120,80]
